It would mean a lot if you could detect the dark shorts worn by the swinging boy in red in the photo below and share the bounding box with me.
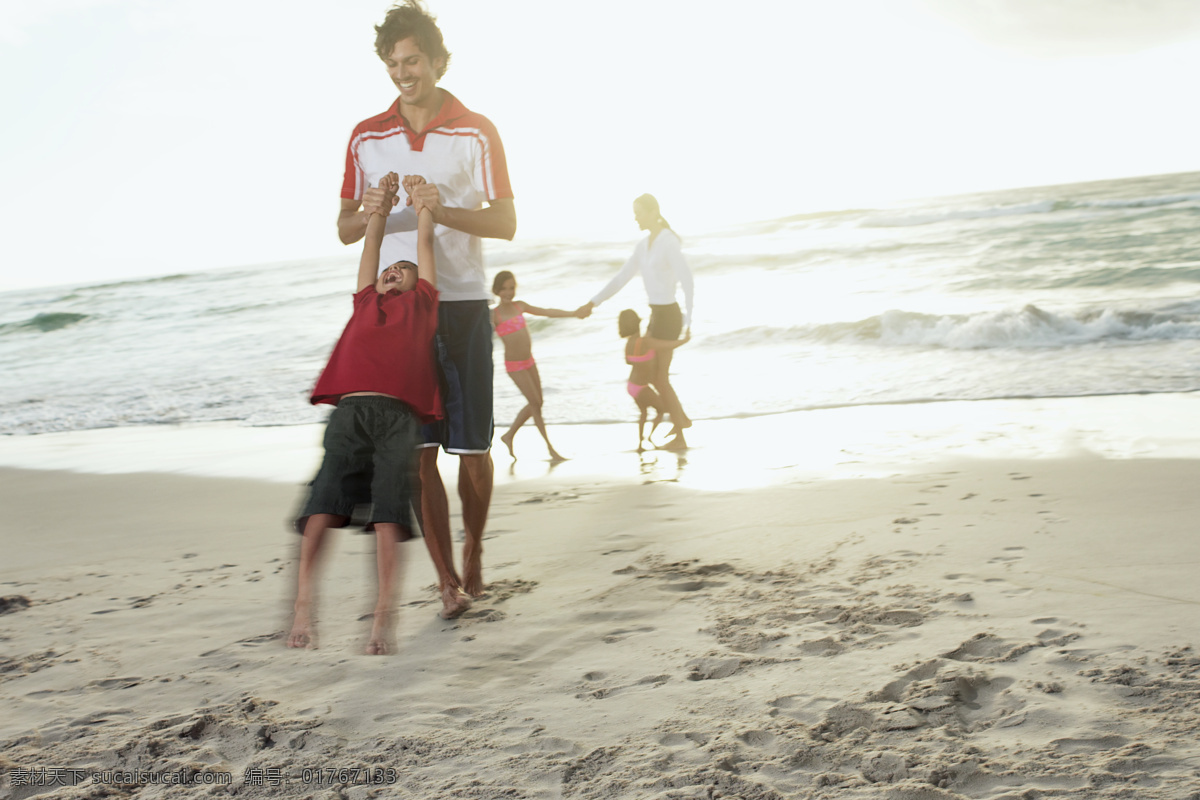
[295,396,420,541]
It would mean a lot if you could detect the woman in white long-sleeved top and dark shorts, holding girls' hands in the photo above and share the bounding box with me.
[578,194,692,450]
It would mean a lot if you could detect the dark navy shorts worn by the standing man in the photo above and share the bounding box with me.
[424,300,493,455]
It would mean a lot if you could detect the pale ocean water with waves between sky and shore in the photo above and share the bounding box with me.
[0,173,1200,435]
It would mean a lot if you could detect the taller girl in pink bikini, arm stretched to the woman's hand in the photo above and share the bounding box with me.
[492,270,580,461]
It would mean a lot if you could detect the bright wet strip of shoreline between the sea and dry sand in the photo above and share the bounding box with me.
[0,392,1200,488]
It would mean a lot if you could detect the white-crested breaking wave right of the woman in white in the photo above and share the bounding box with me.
[812,305,1200,350]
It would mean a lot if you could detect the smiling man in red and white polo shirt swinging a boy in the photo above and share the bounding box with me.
[337,0,517,618]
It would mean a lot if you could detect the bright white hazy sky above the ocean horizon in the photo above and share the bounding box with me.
[0,0,1200,290]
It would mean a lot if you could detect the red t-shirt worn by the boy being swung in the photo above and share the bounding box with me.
[310,281,442,422]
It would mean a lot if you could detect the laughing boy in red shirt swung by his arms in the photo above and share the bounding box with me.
[287,173,442,655]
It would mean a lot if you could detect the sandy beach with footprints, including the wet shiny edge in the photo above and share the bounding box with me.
[0,395,1200,800]
